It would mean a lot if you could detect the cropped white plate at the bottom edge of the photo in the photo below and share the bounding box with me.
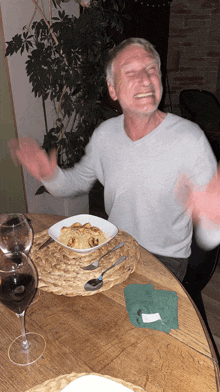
[62,374,132,392]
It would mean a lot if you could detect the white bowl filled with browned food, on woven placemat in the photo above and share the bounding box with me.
[48,214,118,254]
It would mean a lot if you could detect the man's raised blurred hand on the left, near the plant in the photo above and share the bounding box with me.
[9,137,57,181]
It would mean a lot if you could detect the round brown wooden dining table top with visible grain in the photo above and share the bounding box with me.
[0,214,220,392]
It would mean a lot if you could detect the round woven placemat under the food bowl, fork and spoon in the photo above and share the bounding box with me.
[30,230,140,297]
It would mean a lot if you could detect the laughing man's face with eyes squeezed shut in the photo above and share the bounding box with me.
[108,45,162,115]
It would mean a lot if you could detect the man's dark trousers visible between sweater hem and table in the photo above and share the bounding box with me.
[153,254,188,282]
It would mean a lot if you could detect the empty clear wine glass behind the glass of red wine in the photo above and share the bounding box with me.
[0,213,33,257]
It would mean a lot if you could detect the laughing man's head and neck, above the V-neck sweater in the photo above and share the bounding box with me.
[107,41,166,141]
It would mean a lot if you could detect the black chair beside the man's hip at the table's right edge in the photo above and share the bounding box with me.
[182,234,220,363]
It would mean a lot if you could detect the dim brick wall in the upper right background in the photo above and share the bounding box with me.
[165,0,220,114]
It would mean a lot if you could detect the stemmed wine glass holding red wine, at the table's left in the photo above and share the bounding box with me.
[0,252,46,366]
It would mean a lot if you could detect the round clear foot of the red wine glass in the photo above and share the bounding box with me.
[8,332,46,366]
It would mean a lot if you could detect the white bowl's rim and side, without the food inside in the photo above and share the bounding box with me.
[48,214,118,254]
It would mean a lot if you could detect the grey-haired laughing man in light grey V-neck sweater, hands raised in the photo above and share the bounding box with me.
[11,38,220,281]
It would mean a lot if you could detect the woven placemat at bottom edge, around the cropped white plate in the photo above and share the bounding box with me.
[26,373,146,392]
